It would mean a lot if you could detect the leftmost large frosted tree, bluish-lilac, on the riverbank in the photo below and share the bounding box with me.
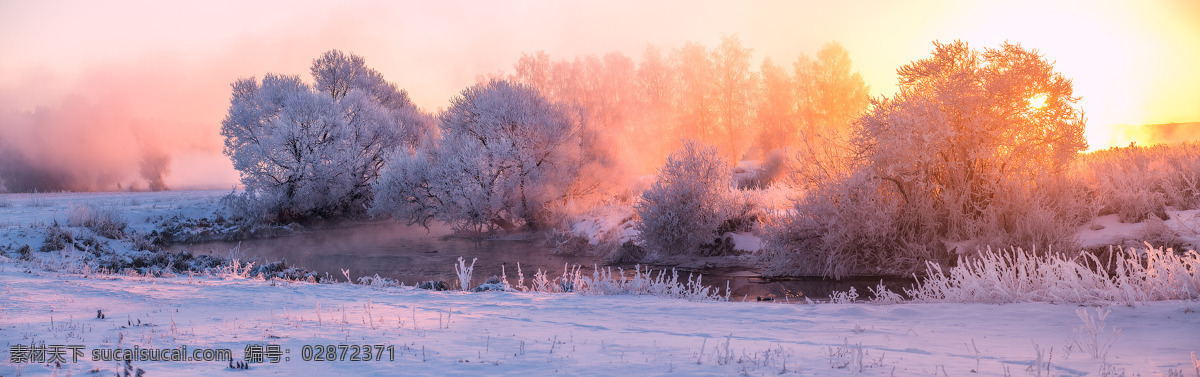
[221,50,433,221]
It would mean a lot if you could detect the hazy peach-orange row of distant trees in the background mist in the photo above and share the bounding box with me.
[509,35,869,172]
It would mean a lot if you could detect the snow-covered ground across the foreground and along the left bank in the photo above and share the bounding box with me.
[0,191,1200,376]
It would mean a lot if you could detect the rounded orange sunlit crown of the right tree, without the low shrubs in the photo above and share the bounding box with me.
[856,41,1087,238]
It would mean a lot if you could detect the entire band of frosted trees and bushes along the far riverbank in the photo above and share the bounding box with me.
[222,40,1092,276]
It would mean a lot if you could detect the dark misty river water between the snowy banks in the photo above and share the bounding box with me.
[172,223,912,301]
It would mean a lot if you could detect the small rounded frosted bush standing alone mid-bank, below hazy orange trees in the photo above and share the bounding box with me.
[634,140,733,255]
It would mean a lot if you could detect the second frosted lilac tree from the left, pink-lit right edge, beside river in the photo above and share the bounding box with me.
[372,79,590,232]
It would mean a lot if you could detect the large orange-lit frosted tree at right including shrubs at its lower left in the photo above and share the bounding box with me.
[768,42,1087,276]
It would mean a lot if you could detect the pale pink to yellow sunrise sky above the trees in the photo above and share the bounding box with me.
[0,0,1200,189]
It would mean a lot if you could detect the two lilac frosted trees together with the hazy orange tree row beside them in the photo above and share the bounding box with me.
[221,36,868,226]
